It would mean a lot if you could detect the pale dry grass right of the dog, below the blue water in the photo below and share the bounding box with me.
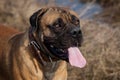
[68,20,120,80]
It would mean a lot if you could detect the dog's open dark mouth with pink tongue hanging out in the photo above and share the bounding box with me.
[44,42,86,68]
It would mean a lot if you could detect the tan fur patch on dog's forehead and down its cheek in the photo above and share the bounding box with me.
[39,8,79,36]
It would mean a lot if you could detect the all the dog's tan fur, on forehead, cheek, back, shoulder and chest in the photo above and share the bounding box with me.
[0,8,79,80]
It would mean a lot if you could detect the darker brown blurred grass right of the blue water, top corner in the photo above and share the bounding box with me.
[80,0,120,24]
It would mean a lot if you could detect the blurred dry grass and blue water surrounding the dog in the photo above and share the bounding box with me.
[0,0,120,80]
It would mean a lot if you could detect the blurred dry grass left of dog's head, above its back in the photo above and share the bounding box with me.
[0,0,40,30]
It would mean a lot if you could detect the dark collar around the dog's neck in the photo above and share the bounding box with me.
[29,28,58,65]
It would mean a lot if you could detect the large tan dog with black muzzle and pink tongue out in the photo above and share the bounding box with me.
[0,7,86,80]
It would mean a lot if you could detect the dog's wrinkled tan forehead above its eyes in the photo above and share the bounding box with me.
[41,8,78,24]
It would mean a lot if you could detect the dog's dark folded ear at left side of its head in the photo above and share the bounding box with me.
[30,8,47,30]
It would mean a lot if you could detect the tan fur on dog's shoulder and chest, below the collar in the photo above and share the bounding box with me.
[0,26,67,80]
